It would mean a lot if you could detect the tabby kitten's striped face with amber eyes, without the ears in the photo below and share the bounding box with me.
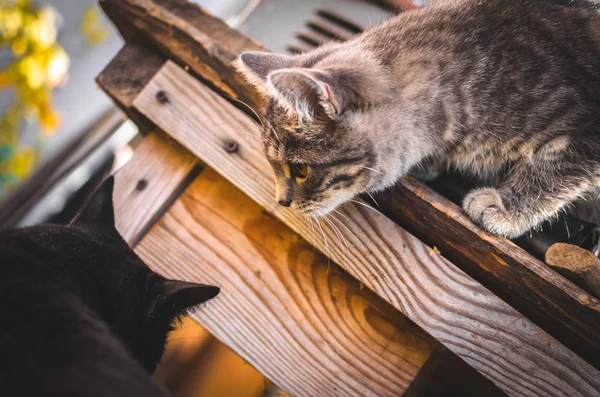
[262,101,377,216]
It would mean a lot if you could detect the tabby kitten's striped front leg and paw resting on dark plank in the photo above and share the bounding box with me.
[463,164,598,238]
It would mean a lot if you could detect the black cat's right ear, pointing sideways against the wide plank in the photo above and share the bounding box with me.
[156,280,221,313]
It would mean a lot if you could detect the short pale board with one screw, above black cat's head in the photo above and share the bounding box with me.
[114,133,198,246]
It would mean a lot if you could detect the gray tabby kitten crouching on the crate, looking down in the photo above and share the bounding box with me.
[238,0,600,238]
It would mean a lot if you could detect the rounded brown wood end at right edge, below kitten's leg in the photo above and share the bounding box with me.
[546,243,600,297]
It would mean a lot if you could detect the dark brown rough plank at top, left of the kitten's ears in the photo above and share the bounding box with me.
[100,0,264,110]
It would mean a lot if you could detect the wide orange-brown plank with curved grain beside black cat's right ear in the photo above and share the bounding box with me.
[136,169,439,396]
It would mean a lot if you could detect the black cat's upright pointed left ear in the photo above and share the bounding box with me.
[71,175,115,226]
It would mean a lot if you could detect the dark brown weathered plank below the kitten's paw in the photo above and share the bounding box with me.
[375,179,600,368]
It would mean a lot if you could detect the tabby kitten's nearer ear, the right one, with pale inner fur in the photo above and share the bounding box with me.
[267,69,343,120]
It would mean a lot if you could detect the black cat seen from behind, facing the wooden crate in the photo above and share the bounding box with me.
[0,177,219,397]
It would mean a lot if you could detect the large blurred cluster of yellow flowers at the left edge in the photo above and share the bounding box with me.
[0,0,69,195]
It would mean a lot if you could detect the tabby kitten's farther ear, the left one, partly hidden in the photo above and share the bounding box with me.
[235,51,295,94]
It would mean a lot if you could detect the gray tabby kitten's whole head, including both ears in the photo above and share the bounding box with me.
[238,46,395,215]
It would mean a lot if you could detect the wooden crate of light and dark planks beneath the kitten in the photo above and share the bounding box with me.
[98,0,600,396]
